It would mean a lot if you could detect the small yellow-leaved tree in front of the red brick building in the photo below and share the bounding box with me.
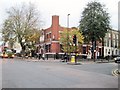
[60,27,84,53]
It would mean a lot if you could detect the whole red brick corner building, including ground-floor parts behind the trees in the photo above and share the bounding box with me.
[40,15,102,58]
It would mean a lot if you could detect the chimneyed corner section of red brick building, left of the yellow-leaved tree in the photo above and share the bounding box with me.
[40,15,65,53]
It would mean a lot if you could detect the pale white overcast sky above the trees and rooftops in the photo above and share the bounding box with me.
[0,0,119,29]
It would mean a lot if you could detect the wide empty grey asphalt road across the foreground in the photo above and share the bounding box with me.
[1,59,118,88]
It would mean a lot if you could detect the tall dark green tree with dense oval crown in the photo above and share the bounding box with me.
[79,1,110,58]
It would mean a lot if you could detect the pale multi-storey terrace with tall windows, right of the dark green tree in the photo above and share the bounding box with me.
[104,30,120,56]
